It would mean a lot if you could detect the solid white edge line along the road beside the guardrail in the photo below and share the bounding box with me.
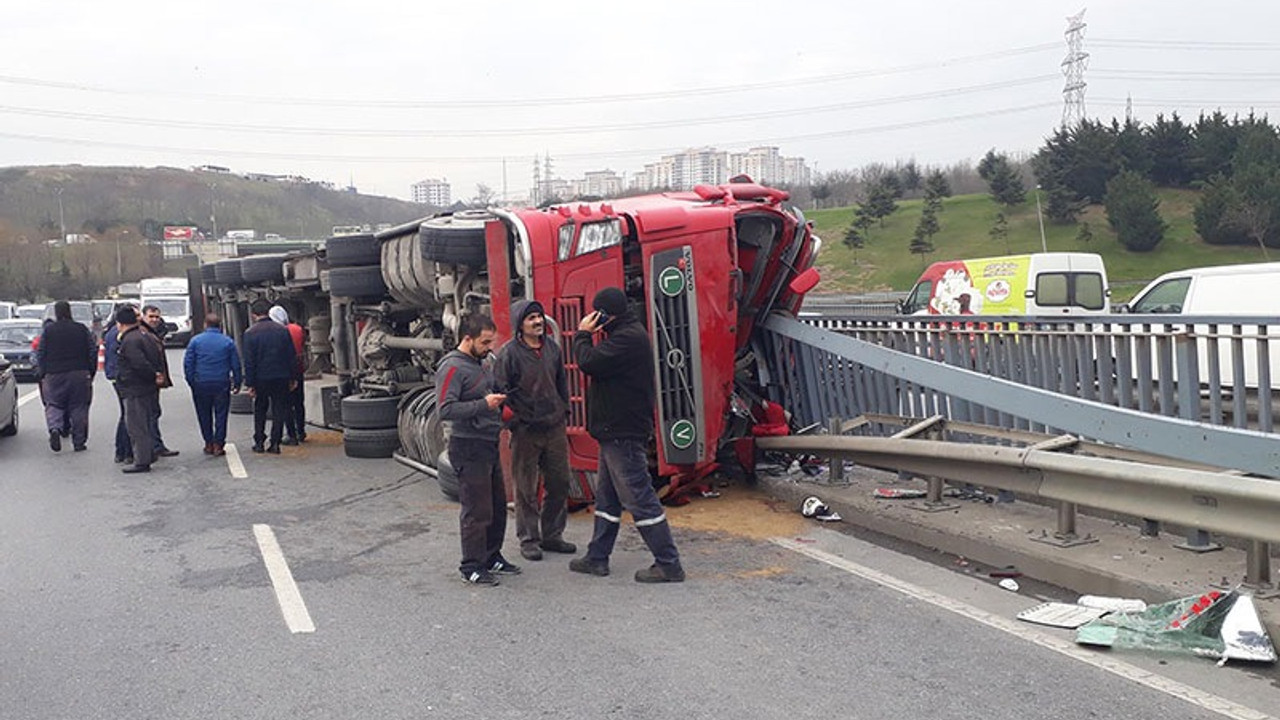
[769,538,1276,720]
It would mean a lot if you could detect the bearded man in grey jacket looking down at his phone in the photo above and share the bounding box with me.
[435,315,520,585]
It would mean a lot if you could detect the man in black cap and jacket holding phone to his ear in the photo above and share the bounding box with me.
[568,287,685,583]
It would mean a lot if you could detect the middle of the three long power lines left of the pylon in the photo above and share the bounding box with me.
[0,74,1056,138]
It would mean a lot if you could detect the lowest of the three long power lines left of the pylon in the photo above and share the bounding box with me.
[0,102,1057,164]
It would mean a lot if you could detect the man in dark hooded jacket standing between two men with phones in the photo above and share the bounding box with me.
[494,300,577,560]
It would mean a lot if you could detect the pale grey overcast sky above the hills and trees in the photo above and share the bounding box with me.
[0,0,1280,199]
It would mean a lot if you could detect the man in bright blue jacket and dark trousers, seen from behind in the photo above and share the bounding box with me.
[182,313,241,455]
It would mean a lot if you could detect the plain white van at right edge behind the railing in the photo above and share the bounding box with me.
[1121,263,1280,388]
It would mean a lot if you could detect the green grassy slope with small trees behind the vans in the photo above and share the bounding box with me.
[806,190,1263,300]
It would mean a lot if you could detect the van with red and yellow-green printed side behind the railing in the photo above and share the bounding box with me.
[902,252,1111,315]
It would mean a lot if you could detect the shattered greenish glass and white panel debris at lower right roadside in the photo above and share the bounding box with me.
[1075,591,1276,665]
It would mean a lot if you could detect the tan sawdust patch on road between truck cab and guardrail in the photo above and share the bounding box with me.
[667,486,805,539]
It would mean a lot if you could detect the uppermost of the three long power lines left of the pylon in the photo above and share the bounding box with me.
[0,42,1056,109]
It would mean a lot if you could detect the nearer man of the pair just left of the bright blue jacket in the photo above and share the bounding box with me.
[115,306,169,473]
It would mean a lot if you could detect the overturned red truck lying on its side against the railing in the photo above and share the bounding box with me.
[206,178,820,501]
